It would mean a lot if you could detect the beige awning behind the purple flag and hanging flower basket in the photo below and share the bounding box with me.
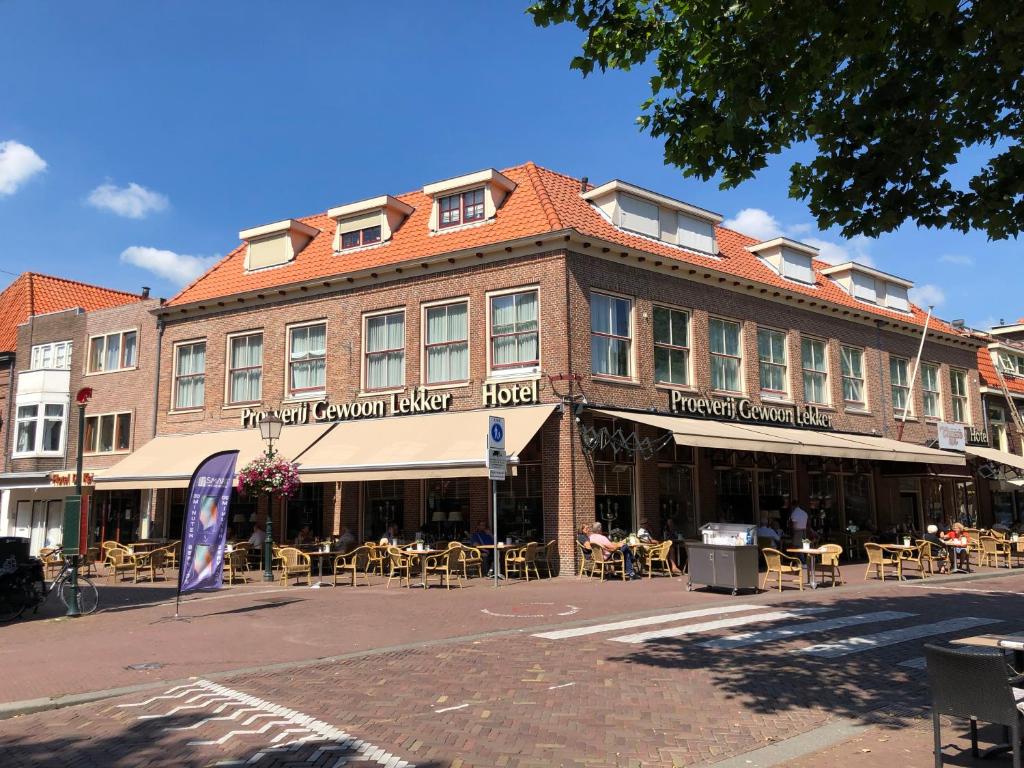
[95,424,330,490]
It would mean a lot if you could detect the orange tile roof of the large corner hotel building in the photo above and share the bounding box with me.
[167,163,958,334]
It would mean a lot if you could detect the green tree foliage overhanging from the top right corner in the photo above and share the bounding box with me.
[528,0,1024,239]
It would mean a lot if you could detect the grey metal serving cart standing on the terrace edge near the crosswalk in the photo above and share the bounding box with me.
[686,522,758,595]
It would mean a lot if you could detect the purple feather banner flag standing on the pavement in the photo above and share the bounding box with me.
[178,451,239,595]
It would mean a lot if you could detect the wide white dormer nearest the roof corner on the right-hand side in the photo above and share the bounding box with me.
[581,179,722,256]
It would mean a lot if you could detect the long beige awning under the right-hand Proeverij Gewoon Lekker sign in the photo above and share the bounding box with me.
[595,409,965,465]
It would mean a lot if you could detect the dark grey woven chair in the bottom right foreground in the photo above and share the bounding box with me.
[925,643,1024,768]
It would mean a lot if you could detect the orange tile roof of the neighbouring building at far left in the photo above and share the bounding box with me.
[0,272,140,352]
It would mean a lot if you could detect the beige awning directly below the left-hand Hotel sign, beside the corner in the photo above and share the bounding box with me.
[298,404,556,482]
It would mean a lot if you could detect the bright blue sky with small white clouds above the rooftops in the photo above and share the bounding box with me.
[0,0,1024,328]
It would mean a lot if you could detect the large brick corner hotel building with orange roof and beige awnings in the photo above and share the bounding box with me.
[97,163,983,568]
